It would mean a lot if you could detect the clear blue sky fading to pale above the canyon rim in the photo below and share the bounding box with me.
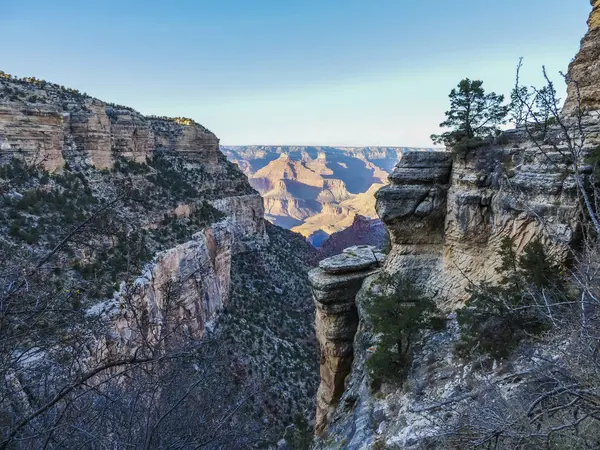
[0,0,591,147]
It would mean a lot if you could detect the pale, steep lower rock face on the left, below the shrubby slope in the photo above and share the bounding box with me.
[105,219,234,348]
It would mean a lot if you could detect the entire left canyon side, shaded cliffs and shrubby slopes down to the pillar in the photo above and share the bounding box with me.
[0,72,318,448]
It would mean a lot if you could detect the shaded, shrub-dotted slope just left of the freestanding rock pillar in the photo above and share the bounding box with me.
[219,223,319,434]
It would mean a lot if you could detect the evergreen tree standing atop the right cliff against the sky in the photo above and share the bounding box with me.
[431,78,508,153]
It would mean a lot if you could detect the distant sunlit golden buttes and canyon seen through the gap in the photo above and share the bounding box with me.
[223,146,429,244]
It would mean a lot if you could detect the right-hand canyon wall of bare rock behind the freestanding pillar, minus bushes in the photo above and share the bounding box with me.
[315,1,600,450]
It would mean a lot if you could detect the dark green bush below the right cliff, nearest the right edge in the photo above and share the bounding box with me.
[456,238,569,358]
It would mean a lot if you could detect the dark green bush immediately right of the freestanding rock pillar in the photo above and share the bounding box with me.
[365,275,444,381]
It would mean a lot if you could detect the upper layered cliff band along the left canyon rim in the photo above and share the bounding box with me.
[0,77,222,171]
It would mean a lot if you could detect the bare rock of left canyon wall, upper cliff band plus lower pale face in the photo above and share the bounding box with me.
[0,74,267,356]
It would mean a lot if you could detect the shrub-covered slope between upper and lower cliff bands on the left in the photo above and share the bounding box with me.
[0,155,223,299]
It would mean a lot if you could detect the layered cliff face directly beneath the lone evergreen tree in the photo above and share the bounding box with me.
[377,141,584,307]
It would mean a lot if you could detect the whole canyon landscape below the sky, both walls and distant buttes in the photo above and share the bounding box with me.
[0,0,600,450]
